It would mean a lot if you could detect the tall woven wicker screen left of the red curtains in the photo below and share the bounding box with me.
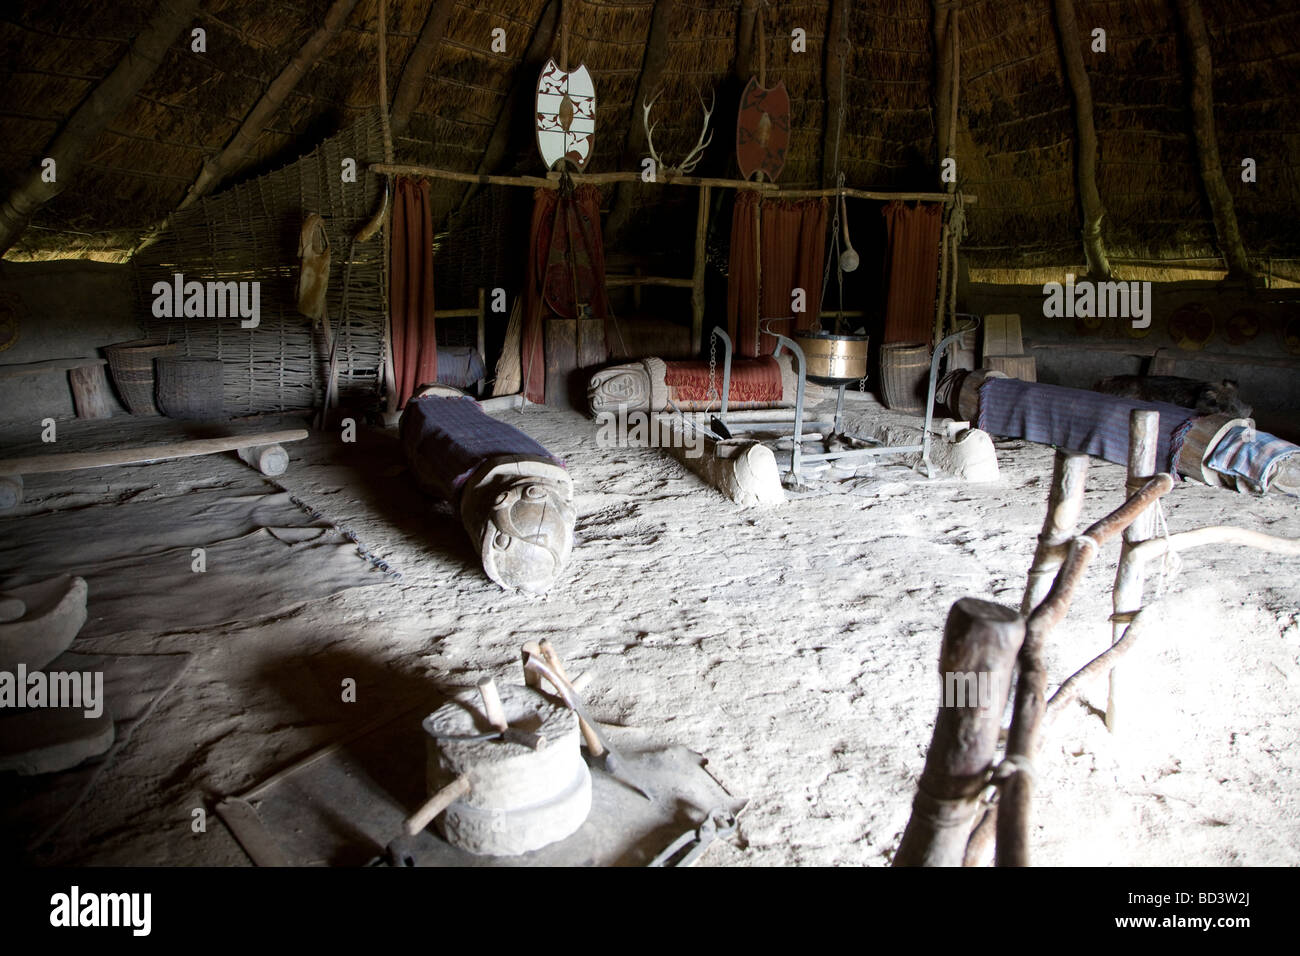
[133,112,385,416]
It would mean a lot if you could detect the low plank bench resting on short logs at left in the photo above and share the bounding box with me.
[0,428,307,511]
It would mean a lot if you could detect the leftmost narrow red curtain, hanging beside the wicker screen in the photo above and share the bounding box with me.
[389,177,438,408]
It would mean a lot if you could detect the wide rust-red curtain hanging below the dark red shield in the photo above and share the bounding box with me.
[727,190,827,358]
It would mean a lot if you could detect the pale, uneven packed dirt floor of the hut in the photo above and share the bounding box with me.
[4,403,1300,866]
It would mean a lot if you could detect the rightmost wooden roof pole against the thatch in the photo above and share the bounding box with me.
[1178,0,1255,278]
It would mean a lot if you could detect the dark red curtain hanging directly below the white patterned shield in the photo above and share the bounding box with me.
[520,185,612,405]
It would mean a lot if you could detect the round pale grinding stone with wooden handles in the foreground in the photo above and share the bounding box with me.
[424,684,592,856]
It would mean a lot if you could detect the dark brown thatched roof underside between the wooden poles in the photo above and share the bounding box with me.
[0,0,1300,274]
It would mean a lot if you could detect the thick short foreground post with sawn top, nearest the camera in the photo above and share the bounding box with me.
[893,597,1024,866]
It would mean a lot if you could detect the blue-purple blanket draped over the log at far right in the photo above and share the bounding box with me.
[979,378,1196,480]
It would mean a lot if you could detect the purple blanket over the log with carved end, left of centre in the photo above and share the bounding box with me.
[400,395,564,499]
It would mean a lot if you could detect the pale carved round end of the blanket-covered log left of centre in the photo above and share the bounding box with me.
[480,477,576,594]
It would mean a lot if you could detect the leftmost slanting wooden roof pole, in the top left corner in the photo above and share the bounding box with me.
[0,0,199,255]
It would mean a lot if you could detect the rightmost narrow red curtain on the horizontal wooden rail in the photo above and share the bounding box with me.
[881,199,944,345]
